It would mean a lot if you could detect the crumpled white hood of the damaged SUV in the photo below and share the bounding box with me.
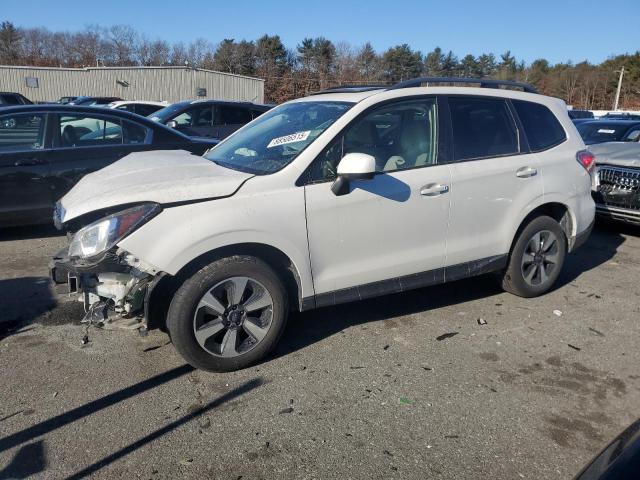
[60,150,253,223]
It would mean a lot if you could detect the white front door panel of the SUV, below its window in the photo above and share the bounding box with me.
[305,165,450,294]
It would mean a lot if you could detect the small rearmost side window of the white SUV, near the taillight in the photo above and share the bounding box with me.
[511,100,567,152]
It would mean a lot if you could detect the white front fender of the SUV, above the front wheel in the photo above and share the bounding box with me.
[118,188,313,297]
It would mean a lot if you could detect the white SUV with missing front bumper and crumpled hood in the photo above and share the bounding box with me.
[52,78,594,371]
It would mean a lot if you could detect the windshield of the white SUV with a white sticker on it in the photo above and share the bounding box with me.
[205,102,353,175]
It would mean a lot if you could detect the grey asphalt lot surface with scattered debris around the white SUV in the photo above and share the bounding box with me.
[0,225,640,480]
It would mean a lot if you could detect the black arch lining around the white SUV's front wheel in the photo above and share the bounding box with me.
[146,242,303,330]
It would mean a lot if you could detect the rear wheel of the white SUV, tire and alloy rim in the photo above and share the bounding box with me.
[501,216,567,298]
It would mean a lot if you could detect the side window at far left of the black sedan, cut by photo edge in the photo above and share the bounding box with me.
[0,113,45,152]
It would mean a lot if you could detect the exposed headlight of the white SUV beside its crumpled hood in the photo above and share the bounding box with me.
[69,203,161,258]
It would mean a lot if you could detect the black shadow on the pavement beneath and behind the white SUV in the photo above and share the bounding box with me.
[272,219,633,358]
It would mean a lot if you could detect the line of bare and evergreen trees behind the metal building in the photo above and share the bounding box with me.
[0,21,640,109]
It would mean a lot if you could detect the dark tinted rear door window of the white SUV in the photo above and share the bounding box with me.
[449,97,520,161]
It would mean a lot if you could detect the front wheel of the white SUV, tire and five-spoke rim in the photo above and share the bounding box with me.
[167,255,289,372]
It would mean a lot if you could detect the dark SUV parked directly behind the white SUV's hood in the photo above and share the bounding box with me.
[149,100,272,139]
